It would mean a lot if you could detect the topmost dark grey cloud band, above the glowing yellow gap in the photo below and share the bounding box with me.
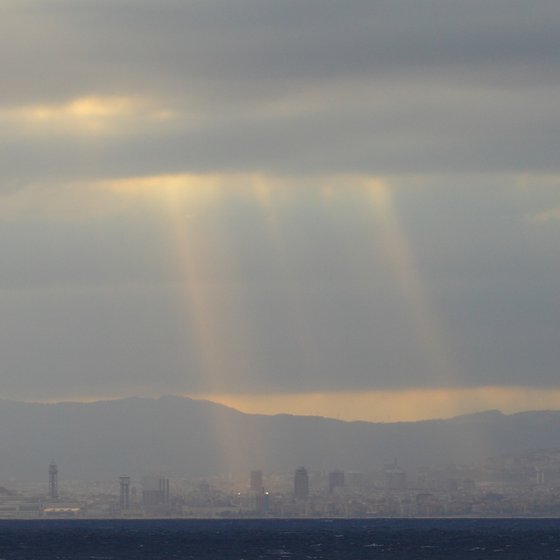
[2,0,560,99]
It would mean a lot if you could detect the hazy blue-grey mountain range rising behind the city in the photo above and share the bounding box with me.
[0,397,560,480]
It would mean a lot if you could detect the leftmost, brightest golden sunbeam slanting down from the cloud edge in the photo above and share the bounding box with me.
[106,175,251,471]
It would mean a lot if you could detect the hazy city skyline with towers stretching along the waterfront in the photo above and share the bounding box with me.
[0,450,560,519]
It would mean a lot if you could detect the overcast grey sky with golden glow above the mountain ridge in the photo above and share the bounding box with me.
[0,0,560,421]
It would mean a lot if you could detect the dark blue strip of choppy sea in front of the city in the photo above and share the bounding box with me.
[0,519,560,560]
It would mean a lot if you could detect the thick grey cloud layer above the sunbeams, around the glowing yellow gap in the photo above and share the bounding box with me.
[0,0,560,180]
